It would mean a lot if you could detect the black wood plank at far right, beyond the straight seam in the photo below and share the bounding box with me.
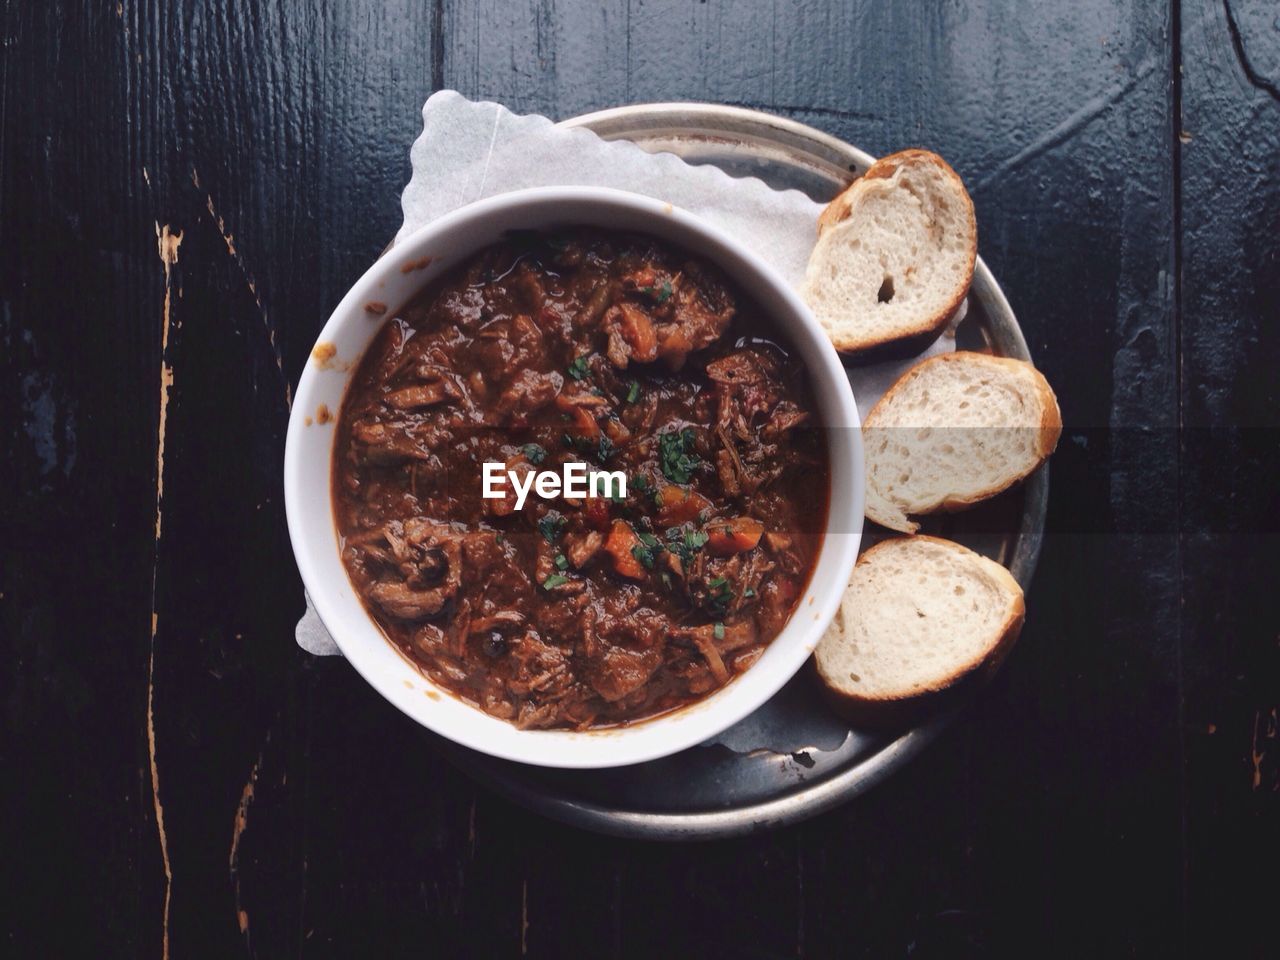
[1179,0,1280,956]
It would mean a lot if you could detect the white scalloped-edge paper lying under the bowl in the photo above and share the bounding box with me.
[297,90,955,655]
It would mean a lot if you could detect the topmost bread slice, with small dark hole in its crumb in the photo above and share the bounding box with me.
[800,150,978,361]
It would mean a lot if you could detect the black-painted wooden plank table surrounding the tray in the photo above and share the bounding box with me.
[0,0,1280,957]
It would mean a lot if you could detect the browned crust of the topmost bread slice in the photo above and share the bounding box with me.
[818,147,978,364]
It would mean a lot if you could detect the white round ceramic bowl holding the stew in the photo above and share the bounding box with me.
[284,187,863,768]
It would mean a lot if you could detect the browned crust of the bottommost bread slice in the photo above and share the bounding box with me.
[813,534,1027,726]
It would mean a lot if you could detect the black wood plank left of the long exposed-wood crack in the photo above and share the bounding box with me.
[0,4,163,956]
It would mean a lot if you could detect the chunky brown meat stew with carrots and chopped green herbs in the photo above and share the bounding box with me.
[333,229,829,728]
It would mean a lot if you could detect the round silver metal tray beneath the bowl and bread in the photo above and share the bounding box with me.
[442,104,1048,840]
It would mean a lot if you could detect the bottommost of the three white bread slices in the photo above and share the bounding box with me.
[814,535,1025,721]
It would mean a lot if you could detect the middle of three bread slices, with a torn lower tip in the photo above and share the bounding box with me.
[863,352,1062,534]
